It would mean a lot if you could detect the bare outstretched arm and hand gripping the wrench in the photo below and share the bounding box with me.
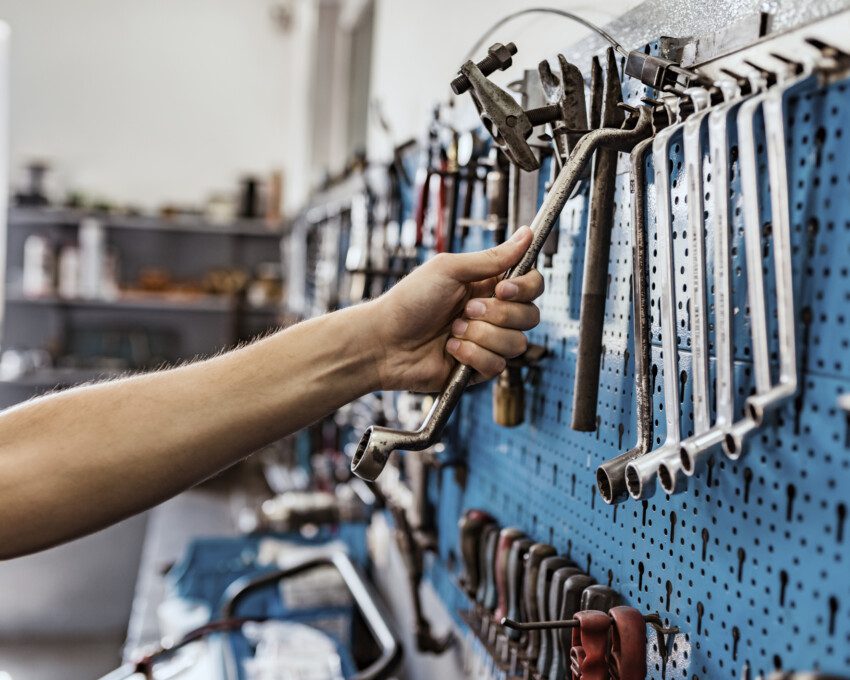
[0,228,543,558]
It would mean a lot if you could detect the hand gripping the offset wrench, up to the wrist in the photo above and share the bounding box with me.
[373,227,543,392]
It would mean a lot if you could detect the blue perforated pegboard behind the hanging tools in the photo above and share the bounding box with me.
[420,54,850,680]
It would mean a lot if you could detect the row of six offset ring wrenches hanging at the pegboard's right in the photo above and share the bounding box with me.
[597,41,850,503]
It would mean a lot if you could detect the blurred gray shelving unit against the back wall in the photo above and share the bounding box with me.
[0,208,283,407]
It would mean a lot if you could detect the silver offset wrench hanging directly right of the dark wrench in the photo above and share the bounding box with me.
[626,94,704,500]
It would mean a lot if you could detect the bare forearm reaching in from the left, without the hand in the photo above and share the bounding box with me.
[0,307,378,557]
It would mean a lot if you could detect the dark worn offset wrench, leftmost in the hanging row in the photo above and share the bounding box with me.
[596,137,653,504]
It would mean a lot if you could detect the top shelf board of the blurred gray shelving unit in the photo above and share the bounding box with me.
[9,208,283,239]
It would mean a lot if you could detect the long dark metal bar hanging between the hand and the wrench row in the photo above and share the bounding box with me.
[571,48,624,432]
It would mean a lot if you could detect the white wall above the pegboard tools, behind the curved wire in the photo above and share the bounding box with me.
[369,0,640,158]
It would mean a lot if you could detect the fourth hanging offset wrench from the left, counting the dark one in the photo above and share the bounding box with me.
[679,81,740,476]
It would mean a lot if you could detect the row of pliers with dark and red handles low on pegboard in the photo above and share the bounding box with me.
[459,509,675,680]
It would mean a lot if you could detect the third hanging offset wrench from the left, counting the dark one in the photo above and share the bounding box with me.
[658,83,738,494]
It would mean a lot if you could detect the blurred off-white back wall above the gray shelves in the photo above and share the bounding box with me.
[0,0,314,212]
